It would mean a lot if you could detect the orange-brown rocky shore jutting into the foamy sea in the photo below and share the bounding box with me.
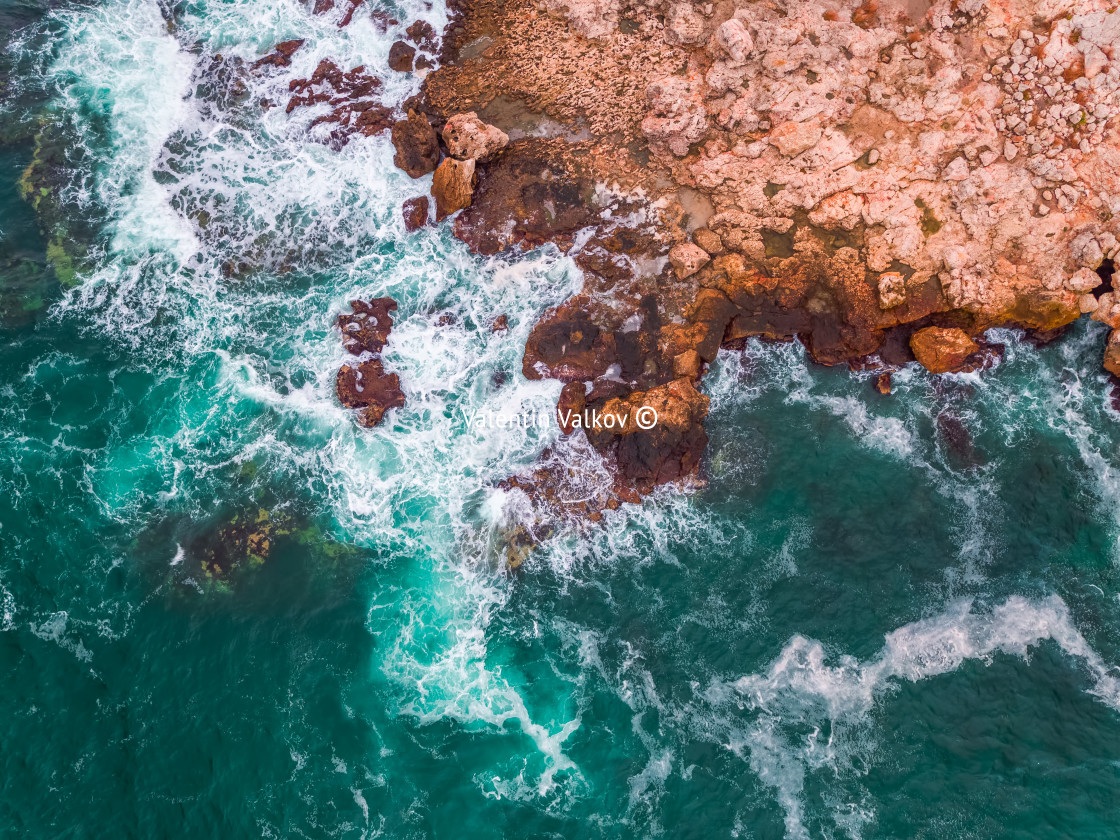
[320,0,1120,514]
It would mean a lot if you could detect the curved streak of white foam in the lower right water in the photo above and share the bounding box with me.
[703,595,1120,838]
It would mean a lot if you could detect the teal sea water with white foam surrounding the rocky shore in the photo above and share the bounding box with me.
[0,0,1120,839]
